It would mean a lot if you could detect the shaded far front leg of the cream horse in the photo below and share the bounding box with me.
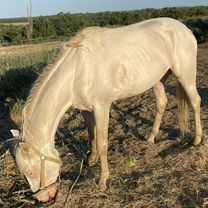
[82,111,98,166]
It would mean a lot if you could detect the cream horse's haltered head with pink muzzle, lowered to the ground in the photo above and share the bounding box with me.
[12,131,61,202]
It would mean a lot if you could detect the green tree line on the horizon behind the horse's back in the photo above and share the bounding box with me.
[0,7,208,45]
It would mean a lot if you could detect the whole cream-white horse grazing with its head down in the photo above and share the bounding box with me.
[13,18,202,201]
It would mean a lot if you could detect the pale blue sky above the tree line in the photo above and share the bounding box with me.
[0,0,208,18]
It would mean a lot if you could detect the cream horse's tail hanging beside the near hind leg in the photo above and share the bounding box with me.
[176,82,189,137]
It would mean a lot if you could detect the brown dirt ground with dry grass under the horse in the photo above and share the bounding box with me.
[0,45,208,208]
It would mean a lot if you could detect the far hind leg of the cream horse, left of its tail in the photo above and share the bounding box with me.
[147,82,167,143]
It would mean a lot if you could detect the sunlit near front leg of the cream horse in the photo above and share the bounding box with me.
[94,104,110,191]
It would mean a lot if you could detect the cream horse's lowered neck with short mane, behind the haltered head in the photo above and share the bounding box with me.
[23,49,77,151]
